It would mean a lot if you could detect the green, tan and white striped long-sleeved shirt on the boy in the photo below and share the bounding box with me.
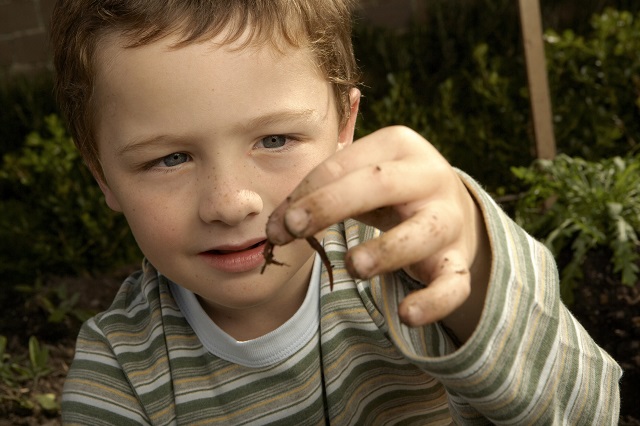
[62,176,621,425]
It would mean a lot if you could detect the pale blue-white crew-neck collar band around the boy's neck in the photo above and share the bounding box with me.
[169,254,322,368]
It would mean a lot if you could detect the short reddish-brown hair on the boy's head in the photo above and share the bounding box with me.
[51,0,358,179]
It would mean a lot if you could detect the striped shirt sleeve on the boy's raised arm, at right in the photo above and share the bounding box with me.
[372,175,622,425]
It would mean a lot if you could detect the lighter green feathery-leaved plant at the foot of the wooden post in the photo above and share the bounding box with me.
[512,155,640,304]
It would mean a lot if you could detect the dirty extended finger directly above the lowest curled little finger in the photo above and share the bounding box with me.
[345,202,458,282]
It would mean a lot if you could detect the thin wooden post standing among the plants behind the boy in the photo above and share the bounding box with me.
[519,0,556,159]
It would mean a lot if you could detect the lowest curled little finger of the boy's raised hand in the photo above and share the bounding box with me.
[398,259,471,327]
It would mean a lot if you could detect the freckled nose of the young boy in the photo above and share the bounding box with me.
[199,176,263,226]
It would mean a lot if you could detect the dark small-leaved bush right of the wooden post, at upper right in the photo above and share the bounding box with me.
[545,9,640,160]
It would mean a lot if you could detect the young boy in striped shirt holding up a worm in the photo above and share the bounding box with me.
[52,0,621,425]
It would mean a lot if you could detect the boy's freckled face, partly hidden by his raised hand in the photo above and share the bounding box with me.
[94,30,357,320]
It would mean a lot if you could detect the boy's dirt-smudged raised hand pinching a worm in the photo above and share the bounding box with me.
[267,126,491,341]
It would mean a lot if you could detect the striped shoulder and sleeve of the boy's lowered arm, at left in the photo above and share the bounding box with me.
[62,261,184,424]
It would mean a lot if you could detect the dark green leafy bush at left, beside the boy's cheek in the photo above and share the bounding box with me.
[0,115,139,283]
